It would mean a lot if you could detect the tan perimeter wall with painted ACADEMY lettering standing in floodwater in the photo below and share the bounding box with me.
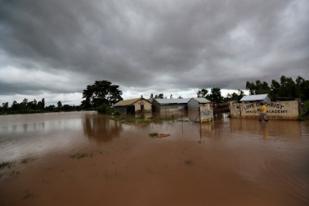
[230,100,299,119]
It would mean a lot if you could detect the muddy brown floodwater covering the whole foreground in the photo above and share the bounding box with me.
[0,112,309,206]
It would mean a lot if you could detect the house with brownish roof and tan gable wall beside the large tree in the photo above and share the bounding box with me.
[113,98,152,114]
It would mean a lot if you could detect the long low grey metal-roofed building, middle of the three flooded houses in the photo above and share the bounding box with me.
[152,98,190,114]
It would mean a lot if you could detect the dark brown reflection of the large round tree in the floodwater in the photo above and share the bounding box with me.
[83,114,122,143]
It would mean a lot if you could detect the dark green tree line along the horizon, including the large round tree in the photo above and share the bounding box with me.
[0,76,309,114]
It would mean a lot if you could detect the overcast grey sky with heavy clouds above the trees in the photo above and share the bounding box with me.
[0,0,309,104]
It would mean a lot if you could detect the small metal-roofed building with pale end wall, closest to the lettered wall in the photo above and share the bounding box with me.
[188,98,213,122]
